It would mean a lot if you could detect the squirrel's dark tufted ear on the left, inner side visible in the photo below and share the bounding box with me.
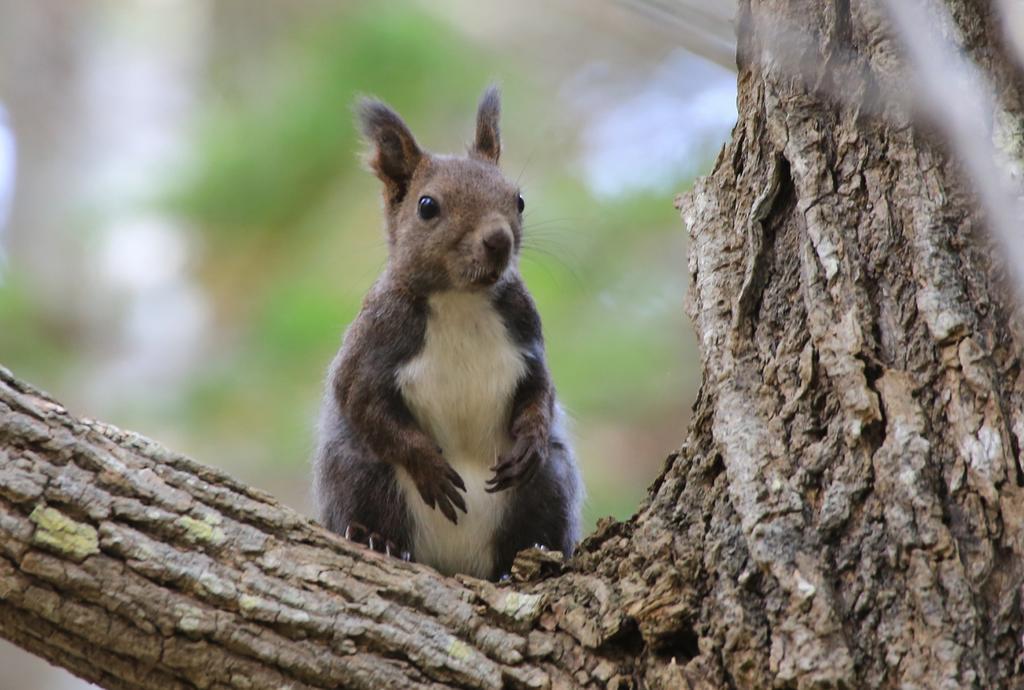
[356,98,423,204]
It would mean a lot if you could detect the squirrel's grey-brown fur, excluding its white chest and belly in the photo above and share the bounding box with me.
[314,88,582,575]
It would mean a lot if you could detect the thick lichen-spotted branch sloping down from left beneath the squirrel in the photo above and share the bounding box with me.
[0,369,626,690]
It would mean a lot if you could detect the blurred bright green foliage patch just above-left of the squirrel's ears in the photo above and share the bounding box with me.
[176,3,490,236]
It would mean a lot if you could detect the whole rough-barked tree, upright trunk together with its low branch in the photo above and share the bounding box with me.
[0,0,1024,688]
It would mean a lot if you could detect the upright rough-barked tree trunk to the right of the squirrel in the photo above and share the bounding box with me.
[655,0,1024,688]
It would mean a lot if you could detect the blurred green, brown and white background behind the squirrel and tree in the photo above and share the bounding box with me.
[0,0,735,690]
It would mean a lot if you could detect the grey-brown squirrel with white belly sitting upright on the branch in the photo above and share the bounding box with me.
[313,86,583,579]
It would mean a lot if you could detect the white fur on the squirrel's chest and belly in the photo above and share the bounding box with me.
[397,292,526,577]
